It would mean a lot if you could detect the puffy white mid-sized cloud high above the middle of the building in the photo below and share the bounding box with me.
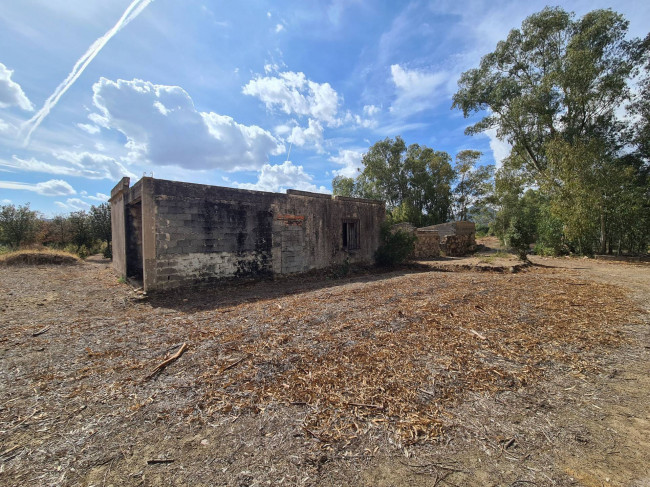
[242,71,340,126]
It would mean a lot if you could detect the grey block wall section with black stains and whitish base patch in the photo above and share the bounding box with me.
[149,180,273,289]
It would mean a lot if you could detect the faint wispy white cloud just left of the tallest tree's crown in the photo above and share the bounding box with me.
[390,64,449,116]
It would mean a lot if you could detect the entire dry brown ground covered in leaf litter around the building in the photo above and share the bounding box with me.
[0,250,650,487]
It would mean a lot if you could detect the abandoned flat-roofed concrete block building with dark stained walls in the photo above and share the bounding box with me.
[110,177,385,291]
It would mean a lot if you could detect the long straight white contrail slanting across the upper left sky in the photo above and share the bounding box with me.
[22,0,153,145]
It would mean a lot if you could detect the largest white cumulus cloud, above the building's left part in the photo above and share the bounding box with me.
[89,78,285,171]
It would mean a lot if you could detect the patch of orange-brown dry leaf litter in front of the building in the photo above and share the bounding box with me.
[176,271,629,444]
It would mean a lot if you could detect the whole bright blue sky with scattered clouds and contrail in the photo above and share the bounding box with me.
[0,0,650,216]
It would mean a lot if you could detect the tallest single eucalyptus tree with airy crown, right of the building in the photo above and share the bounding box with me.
[453,8,642,252]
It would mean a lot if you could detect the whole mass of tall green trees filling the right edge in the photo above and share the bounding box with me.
[453,8,650,254]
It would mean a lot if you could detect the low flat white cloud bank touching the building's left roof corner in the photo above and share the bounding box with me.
[0,151,134,181]
